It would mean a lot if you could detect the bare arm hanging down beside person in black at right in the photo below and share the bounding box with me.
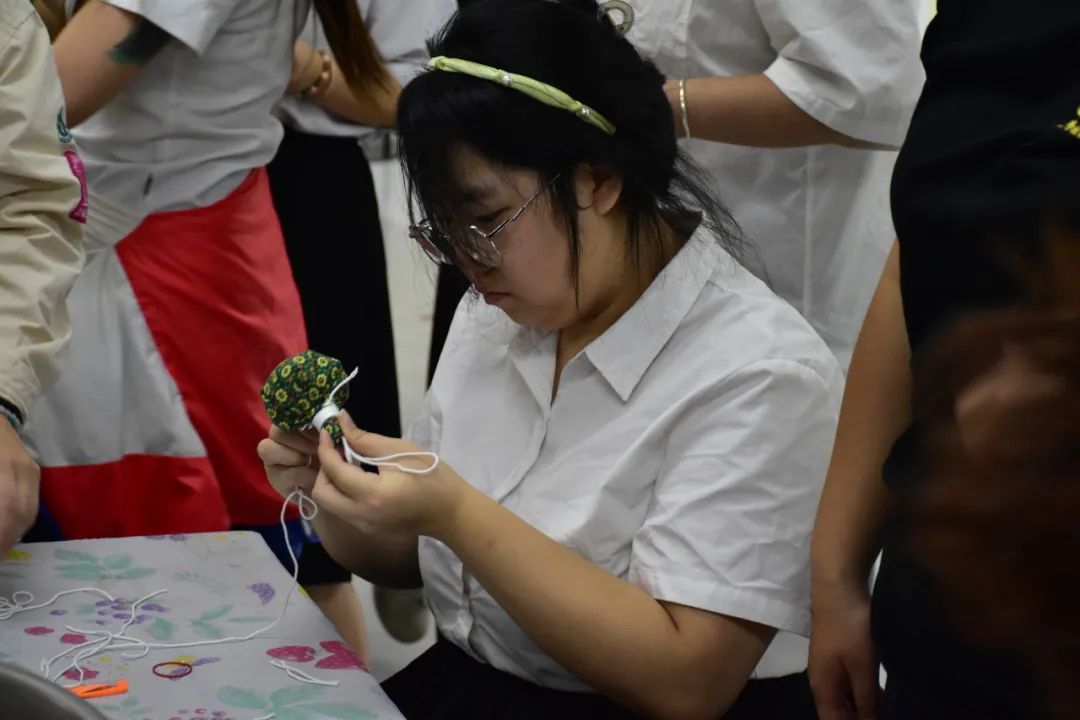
[810,245,912,720]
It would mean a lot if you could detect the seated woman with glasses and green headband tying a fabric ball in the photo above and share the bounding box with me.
[259,0,842,719]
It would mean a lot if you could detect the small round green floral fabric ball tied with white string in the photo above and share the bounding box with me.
[262,350,349,441]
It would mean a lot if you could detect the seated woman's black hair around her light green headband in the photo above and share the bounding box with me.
[397,0,739,283]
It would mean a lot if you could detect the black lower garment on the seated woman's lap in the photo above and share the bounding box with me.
[382,636,818,720]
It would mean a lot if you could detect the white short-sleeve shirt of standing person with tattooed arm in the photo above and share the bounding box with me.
[73,0,310,216]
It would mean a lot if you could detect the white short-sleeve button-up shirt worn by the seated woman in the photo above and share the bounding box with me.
[410,230,842,690]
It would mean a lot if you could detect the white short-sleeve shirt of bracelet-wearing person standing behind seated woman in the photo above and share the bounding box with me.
[630,0,923,368]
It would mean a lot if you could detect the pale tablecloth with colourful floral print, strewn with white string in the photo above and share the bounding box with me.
[0,532,402,720]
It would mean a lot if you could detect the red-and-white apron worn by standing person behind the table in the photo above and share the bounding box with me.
[31,169,306,539]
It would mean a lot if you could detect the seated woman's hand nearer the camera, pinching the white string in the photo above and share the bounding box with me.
[308,412,468,539]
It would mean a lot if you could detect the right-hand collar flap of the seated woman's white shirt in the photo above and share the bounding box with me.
[584,226,726,403]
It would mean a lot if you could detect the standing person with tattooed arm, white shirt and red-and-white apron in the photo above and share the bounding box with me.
[19,0,388,643]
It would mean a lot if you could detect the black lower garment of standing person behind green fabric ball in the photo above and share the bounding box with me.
[269,131,404,585]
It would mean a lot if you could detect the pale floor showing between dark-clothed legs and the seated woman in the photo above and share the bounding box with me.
[354,161,435,680]
